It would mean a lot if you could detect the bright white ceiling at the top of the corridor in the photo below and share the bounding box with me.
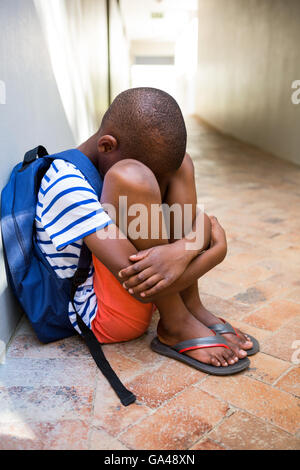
[120,0,198,41]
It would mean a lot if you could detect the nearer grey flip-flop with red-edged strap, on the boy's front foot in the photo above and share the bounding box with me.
[151,334,250,375]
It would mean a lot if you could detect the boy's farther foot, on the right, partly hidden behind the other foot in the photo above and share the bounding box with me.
[188,305,253,359]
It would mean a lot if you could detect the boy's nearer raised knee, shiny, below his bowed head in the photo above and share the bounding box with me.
[105,159,160,195]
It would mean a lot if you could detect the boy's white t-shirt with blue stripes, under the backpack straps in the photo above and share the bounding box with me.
[35,159,112,332]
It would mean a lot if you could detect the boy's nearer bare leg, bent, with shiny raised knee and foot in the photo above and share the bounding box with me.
[101,160,238,366]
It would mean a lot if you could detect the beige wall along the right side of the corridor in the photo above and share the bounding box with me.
[196,0,300,164]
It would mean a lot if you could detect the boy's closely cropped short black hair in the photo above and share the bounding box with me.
[100,87,187,174]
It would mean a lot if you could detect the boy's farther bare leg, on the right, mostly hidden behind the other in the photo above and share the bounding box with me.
[164,155,253,358]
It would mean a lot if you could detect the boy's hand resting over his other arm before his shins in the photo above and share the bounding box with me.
[119,240,191,297]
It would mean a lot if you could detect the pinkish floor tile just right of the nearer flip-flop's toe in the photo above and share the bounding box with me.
[245,353,291,384]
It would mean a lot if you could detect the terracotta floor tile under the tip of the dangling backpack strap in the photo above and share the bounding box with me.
[93,377,151,436]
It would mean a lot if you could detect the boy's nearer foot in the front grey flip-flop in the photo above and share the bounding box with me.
[157,315,239,367]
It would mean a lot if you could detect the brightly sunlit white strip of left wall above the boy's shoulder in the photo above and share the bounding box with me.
[34,0,109,144]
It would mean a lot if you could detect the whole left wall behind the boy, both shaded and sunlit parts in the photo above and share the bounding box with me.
[0,0,108,343]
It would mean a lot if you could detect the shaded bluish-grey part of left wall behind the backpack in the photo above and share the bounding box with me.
[0,0,75,342]
